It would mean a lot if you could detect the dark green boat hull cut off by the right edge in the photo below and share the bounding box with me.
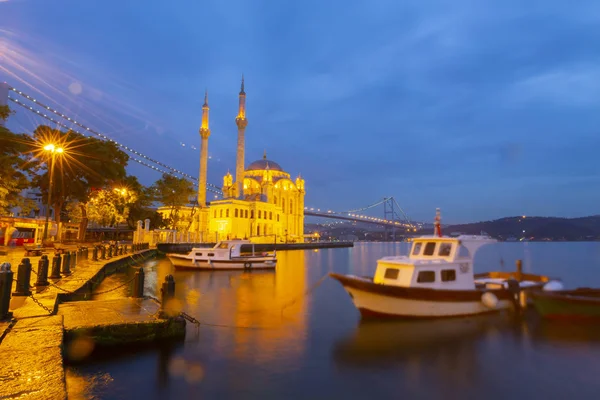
[530,289,600,321]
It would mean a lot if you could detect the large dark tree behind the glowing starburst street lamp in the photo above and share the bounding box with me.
[34,125,129,240]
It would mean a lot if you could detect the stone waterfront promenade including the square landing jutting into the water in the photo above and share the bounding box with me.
[0,248,180,399]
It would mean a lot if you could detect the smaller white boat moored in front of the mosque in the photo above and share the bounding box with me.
[167,239,277,271]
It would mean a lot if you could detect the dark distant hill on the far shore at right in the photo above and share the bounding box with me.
[442,215,600,240]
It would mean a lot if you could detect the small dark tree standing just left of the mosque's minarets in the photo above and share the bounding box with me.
[151,174,195,229]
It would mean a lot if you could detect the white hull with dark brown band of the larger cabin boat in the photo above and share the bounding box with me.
[330,273,514,318]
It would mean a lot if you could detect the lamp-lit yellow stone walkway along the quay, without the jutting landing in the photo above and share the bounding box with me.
[0,248,157,399]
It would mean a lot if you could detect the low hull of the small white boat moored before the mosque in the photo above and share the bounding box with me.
[167,254,277,271]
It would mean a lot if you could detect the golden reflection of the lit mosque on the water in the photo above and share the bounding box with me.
[145,251,307,363]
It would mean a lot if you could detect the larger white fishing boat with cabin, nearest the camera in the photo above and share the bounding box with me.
[329,209,550,318]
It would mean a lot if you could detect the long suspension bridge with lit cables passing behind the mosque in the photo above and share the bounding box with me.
[0,83,420,234]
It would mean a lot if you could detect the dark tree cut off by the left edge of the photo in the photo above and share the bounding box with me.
[0,106,35,215]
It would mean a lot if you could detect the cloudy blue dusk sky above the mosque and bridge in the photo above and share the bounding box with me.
[0,0,600,223]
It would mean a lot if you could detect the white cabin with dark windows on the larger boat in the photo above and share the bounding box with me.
[373,235,496,290]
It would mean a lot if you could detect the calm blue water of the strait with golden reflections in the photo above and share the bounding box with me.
[67,242,600,399]
